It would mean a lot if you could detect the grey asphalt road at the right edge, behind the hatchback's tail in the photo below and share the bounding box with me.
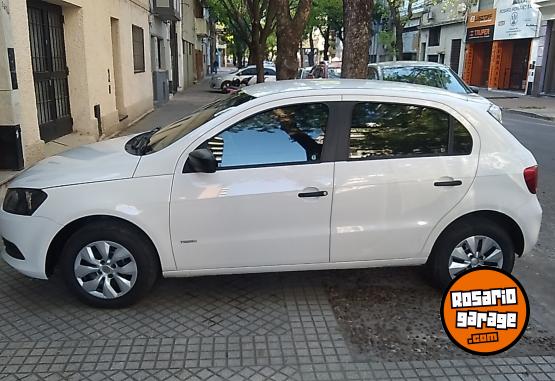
[503,112,555,332]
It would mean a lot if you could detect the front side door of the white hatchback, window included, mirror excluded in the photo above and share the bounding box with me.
[170,97,338,270]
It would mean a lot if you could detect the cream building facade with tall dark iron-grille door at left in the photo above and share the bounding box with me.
[0,0,153,169]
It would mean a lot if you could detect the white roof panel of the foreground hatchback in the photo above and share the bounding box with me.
[243,79,467,99]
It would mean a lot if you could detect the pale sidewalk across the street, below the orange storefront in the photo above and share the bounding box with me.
[479,89,555,121]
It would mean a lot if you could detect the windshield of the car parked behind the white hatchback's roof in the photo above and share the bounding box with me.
[382,66,471,94]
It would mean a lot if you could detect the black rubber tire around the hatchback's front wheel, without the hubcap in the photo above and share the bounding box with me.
[60,221,160,308]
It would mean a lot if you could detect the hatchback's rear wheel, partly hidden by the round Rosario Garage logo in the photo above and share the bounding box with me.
[428,219,515,288]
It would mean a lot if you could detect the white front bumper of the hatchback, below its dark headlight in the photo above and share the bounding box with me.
[0,210,62,279]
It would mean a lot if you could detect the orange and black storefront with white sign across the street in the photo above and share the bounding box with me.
[463,0,541,94]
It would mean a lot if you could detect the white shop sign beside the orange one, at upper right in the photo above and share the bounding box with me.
[493,0,540,40]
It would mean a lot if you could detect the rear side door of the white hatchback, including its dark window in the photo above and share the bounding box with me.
[330,97,479,263]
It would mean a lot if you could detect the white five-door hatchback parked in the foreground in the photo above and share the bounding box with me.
[0,80,542,307]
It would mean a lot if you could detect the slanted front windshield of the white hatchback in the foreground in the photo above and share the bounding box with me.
[145,91,254,154]
